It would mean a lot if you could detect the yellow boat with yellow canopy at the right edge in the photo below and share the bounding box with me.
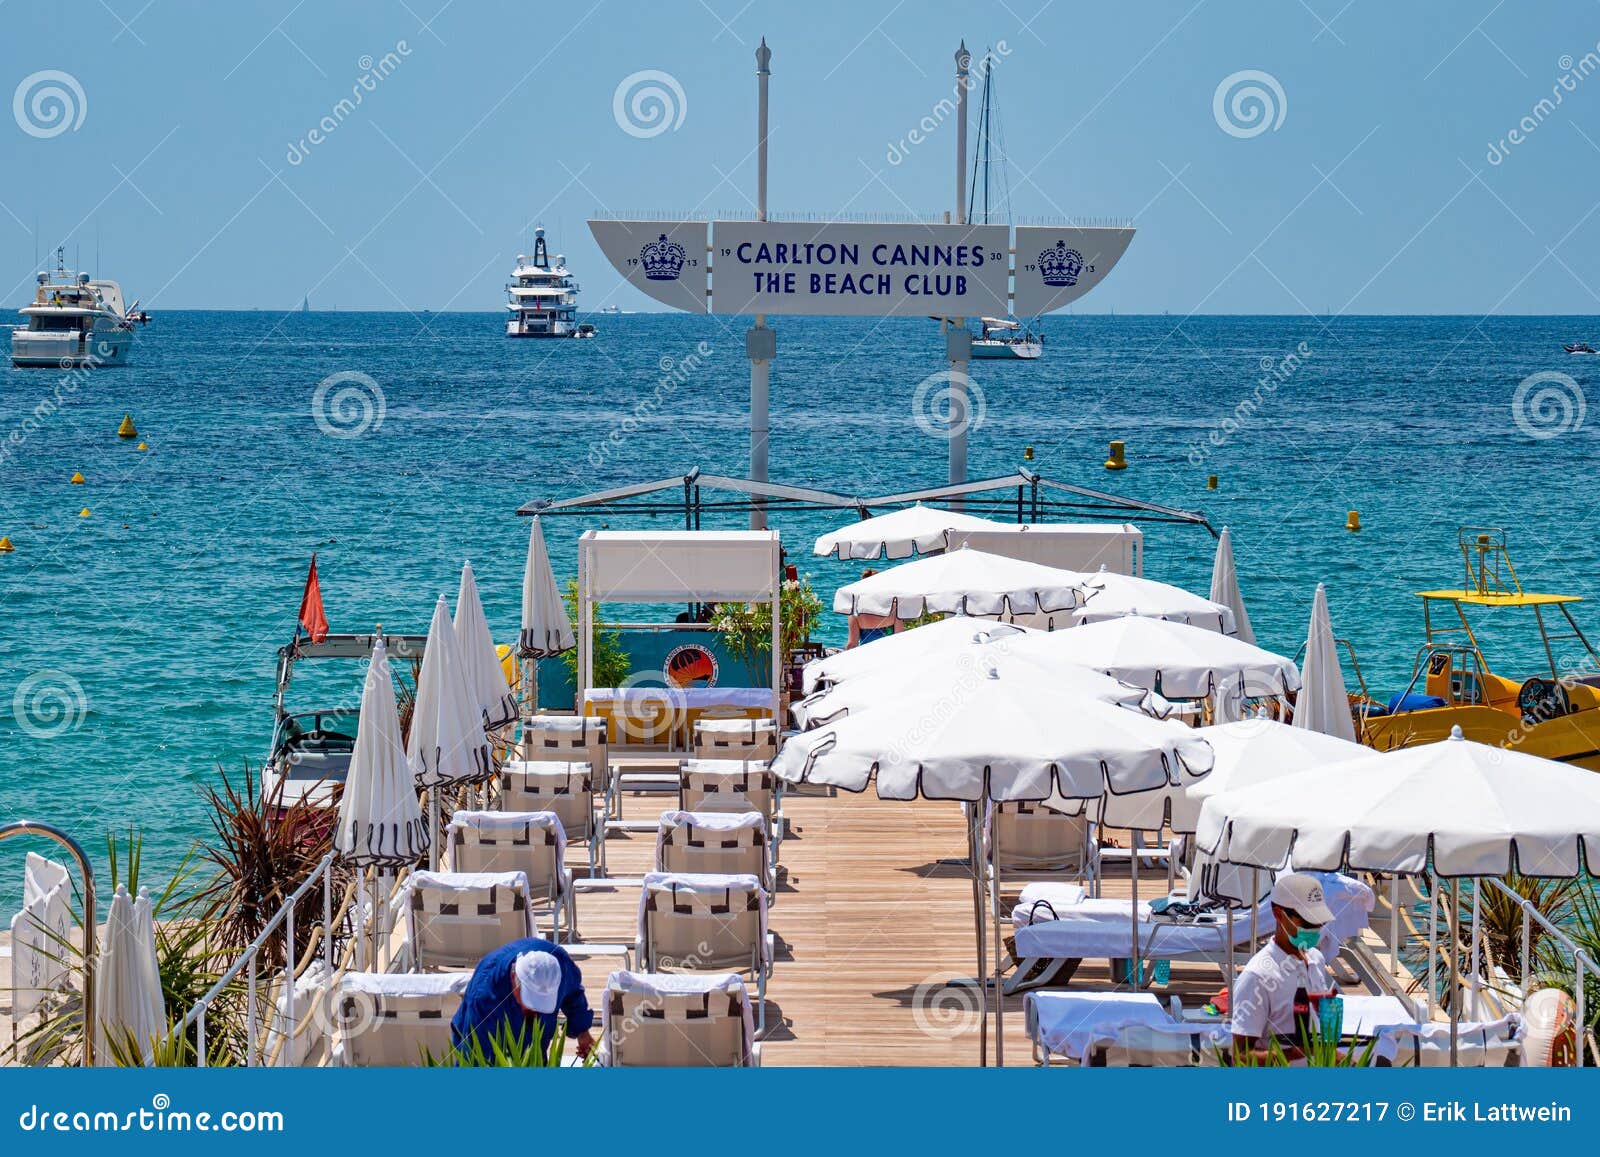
[1354,526,1600,771]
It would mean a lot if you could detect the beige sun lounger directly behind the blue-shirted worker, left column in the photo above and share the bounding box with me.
[405,872,534,971]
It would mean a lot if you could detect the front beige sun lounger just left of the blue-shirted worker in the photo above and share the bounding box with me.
[333,971,472,1067]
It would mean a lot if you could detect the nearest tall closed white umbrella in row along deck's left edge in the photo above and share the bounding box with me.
[334,637,427,867]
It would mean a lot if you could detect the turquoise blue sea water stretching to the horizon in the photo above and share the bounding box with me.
[0,312,1600,912]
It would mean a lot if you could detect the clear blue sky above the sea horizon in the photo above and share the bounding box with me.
[0,0,1600,314]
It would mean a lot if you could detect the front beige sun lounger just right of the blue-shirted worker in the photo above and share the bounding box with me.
[598,971,762,1067]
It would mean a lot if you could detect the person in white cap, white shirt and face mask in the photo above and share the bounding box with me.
[1229,872,1338,1059]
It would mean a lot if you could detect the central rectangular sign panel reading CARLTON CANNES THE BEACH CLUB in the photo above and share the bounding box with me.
[712,221,1010,317]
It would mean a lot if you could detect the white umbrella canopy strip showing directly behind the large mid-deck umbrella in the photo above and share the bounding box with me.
[789,627,1171,728]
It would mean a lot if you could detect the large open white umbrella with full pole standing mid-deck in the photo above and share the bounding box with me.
[773,663,1211,1063]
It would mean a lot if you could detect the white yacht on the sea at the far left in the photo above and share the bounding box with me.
[11,248,138,370]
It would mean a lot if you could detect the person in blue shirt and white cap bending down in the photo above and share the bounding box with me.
[450,936,595,1056]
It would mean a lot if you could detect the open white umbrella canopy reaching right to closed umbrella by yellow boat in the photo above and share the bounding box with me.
[985,615,1299,699]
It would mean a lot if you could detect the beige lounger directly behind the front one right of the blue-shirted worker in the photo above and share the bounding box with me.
[638,872,773,1034]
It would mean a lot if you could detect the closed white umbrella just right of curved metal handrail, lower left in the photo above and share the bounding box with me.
[94,885,166,1066]
